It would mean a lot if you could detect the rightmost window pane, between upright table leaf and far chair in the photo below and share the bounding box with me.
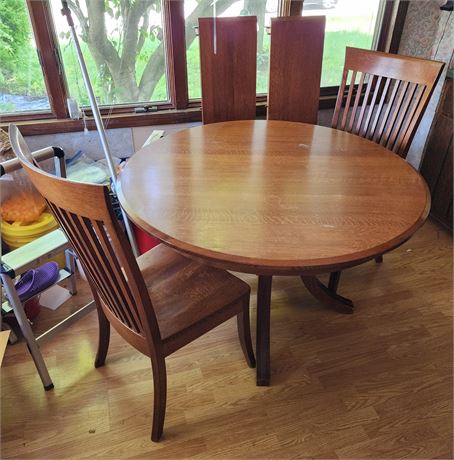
[303,0,382,87]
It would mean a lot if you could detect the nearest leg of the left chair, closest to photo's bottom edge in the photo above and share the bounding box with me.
[151,356,167,442]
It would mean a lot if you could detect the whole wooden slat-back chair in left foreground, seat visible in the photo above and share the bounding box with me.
[10,126,255,441]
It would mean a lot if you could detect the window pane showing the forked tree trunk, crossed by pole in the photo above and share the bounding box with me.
[48,0,168,105]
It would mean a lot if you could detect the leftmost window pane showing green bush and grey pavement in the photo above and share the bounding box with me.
[0,0,50,114]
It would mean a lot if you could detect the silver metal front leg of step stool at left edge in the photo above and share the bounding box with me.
[1,274,54,390]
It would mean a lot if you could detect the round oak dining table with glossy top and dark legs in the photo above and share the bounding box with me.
[117,120,430,385]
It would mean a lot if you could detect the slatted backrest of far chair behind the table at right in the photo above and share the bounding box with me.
[332,47,444,158]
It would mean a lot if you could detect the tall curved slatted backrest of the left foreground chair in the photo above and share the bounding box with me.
[9,125,162,355]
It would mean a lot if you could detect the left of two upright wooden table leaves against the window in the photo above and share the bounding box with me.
[199,16,257,124]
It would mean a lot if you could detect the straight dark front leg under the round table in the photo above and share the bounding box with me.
[256,276,273,386]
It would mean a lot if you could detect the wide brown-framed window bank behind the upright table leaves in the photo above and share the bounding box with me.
[0,0,402,129]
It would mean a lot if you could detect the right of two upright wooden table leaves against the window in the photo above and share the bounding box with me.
[267,16,326,124]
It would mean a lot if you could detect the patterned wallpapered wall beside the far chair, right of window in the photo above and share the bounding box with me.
[399,0,454,169]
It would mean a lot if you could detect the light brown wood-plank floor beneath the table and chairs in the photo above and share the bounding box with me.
[1,223,453,459]
